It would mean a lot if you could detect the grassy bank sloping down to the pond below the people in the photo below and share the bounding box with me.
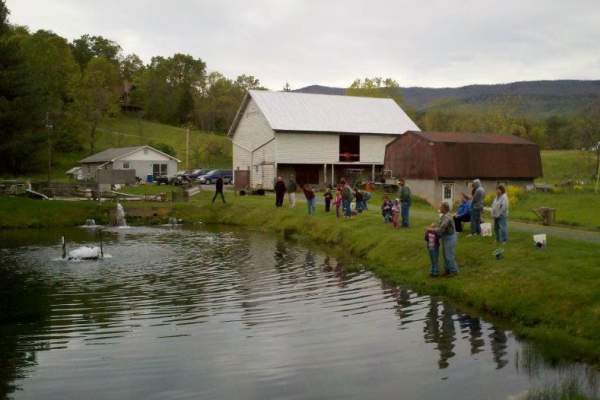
[0,193,600,362]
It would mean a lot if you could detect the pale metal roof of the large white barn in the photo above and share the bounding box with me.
[229,90,419,135]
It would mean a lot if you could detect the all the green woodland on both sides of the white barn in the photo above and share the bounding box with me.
[0,0,600,175]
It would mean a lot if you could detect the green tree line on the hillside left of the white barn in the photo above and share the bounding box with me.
[0,0,261,174]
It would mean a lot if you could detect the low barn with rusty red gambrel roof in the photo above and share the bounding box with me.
[384,131,542,204]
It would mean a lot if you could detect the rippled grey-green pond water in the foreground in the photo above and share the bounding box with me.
[0,228,598,399]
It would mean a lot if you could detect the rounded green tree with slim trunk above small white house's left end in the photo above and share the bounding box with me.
[74,57,121,153]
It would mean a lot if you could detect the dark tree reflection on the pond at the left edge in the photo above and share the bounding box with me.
[0,265,50,399]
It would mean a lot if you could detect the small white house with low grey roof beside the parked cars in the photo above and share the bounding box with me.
[79,146,180,180]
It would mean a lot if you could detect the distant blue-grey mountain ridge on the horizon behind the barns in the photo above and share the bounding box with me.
[296,80,600,118]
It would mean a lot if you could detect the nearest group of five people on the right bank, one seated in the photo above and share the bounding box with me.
[425,179,508,277]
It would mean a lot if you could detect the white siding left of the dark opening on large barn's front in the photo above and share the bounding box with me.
[276,133,340,164]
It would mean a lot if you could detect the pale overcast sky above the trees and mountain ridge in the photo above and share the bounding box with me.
[7,0,600,89]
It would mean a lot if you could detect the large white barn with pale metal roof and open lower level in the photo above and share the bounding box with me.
[229,90,419,189]
